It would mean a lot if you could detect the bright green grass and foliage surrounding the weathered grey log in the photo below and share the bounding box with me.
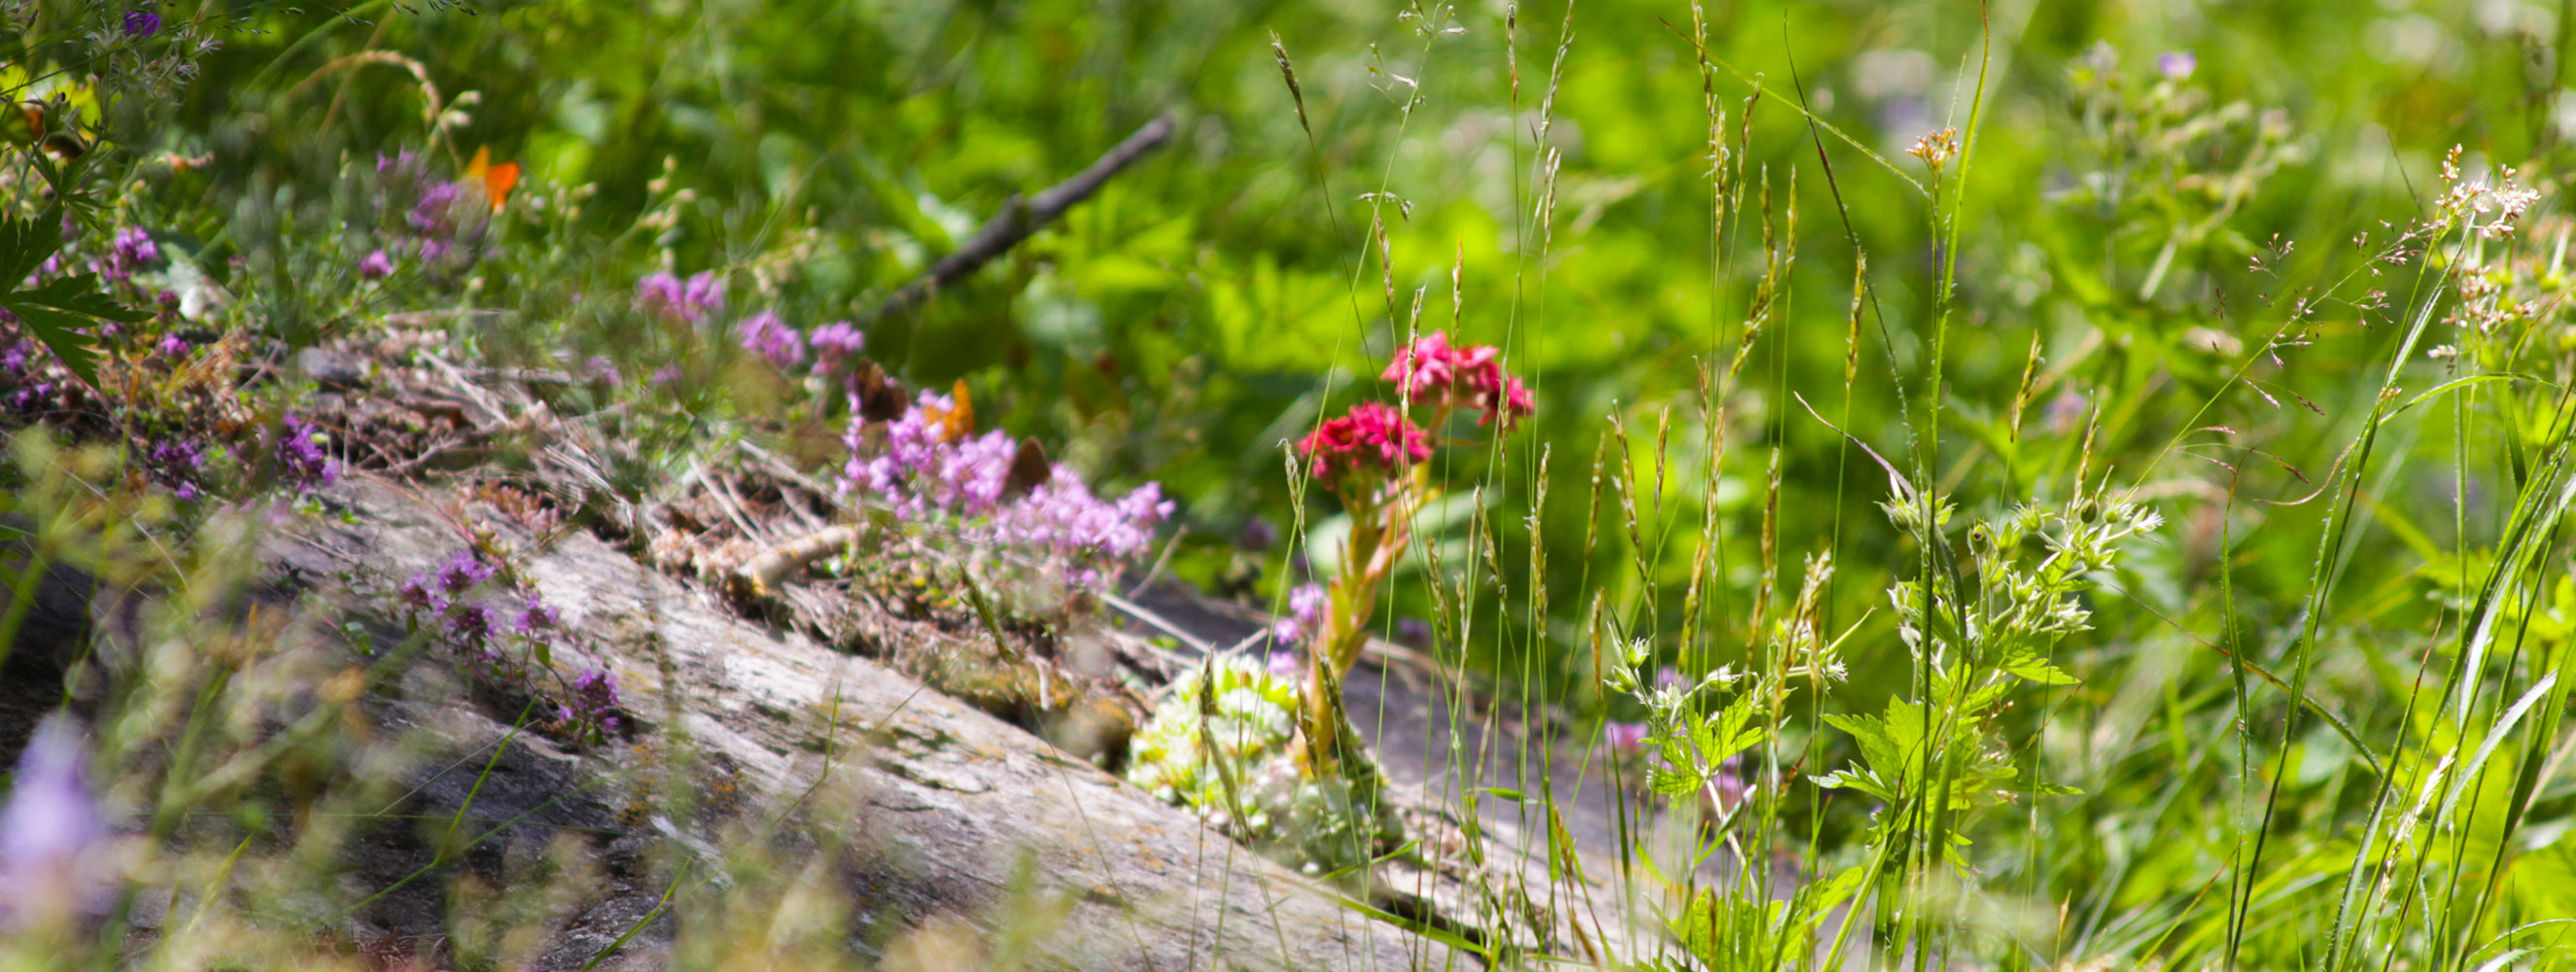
[0,0,2576,972]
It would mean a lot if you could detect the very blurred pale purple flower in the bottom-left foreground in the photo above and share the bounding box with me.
[0,712,108,928]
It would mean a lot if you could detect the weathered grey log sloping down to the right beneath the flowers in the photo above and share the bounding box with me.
[265,482,1474,969]
